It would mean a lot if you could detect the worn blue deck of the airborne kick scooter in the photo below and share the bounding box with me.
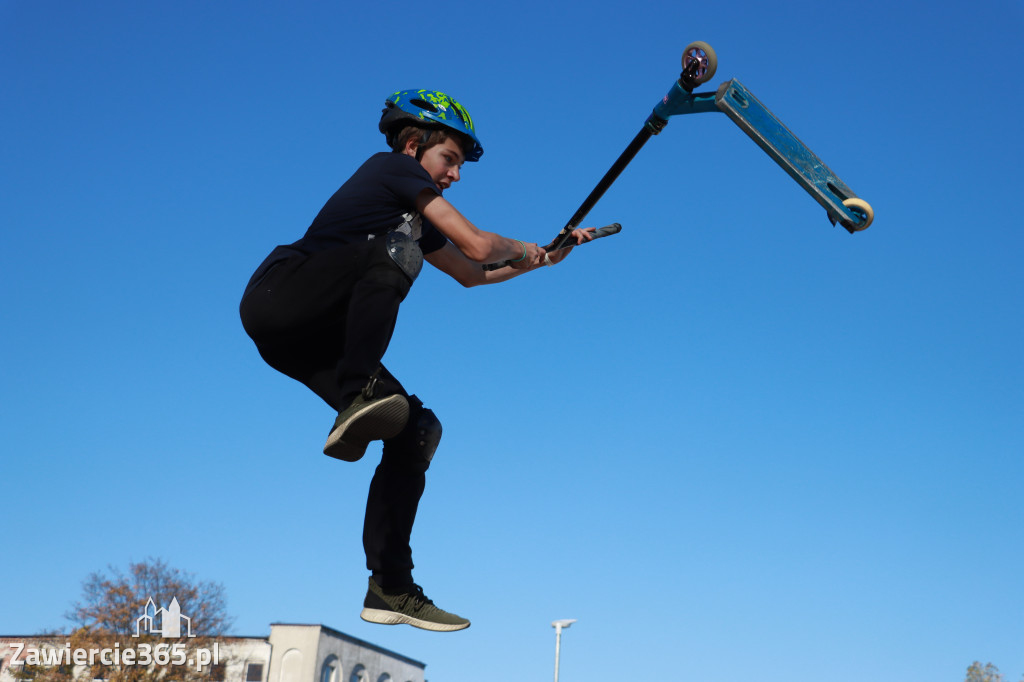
[715,79,864,232]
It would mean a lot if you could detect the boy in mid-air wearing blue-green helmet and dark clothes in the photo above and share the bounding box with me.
[240,90,592,631]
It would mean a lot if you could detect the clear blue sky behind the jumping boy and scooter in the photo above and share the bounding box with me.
[0,0,1024,682]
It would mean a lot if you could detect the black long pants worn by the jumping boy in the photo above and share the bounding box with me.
[240,239,428,587]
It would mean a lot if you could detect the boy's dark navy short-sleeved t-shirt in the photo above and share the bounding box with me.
[292,152,446,254]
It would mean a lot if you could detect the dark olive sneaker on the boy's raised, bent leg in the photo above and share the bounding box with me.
[324,393,409,462]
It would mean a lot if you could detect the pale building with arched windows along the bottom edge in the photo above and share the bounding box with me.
[0,623,426,682]
